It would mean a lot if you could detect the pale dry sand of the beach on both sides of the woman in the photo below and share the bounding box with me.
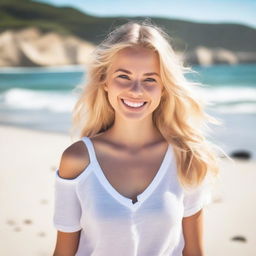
[0,125,256,256]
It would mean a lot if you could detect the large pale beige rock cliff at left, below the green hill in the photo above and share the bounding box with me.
[0,28,95,67]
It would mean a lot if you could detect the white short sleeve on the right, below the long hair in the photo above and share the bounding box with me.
[183,175,212,217]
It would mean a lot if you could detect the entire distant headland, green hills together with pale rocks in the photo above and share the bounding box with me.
[0,0,256,67]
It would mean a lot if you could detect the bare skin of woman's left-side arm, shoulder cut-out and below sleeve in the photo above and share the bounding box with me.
[53,141,89,256]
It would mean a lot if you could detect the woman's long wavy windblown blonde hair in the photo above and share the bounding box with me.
[71,19,228,187]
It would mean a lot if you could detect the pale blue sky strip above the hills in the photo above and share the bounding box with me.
[34,0,256,28]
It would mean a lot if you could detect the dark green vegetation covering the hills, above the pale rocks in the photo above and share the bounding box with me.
[0,0,256,51]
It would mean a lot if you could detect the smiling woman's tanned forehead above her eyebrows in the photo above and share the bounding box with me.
[111,46,159,72]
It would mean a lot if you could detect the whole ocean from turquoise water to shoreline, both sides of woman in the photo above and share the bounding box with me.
[0,64,256,159]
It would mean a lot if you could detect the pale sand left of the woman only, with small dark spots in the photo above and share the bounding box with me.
[0,126,70,256]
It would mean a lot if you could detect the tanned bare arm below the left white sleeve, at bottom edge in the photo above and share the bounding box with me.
[53,231,81,256]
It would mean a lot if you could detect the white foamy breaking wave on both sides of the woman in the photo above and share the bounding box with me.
[0,87,256,114]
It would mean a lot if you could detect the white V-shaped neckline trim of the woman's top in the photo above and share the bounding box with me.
[82,136,173,211]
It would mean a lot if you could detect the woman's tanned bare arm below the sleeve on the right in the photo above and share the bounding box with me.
[182,209,205,256]
